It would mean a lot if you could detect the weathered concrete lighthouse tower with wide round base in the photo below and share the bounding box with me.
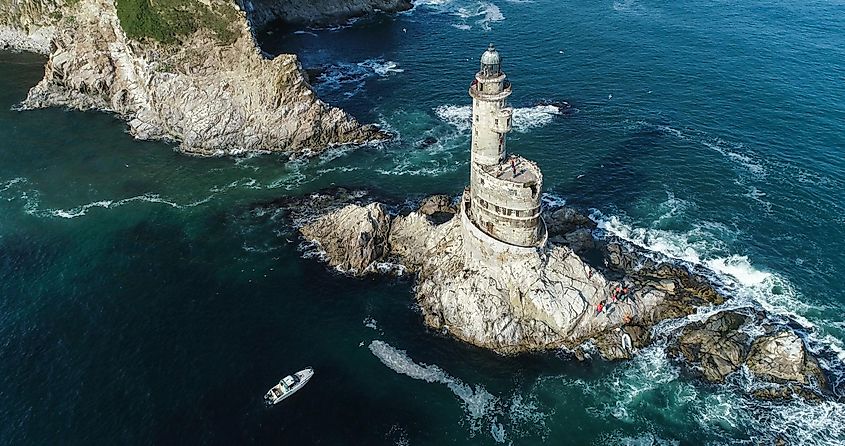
[464,43,546,247]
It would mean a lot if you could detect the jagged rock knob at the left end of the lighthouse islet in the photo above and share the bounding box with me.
[300,203,390,275]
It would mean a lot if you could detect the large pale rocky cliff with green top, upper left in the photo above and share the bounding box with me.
[0,0,388,155]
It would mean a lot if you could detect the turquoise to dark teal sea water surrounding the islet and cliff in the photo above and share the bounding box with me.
[0,0,845,445]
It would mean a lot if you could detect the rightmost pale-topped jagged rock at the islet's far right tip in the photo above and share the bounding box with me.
[746,329,827,388]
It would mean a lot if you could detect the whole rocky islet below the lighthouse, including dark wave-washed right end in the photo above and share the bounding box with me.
[290,190,828,400]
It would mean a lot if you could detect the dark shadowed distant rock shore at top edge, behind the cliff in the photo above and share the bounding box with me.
[238,0,413,28]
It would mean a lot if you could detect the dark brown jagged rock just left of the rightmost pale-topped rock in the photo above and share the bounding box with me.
[674,311,750,382]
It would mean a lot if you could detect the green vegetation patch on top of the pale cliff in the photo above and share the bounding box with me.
[117,0,238,44]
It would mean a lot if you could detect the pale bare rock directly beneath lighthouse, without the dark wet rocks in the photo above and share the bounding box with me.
[301,200,676,357]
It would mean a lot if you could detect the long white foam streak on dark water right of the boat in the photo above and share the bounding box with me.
[370,340,497,432]
